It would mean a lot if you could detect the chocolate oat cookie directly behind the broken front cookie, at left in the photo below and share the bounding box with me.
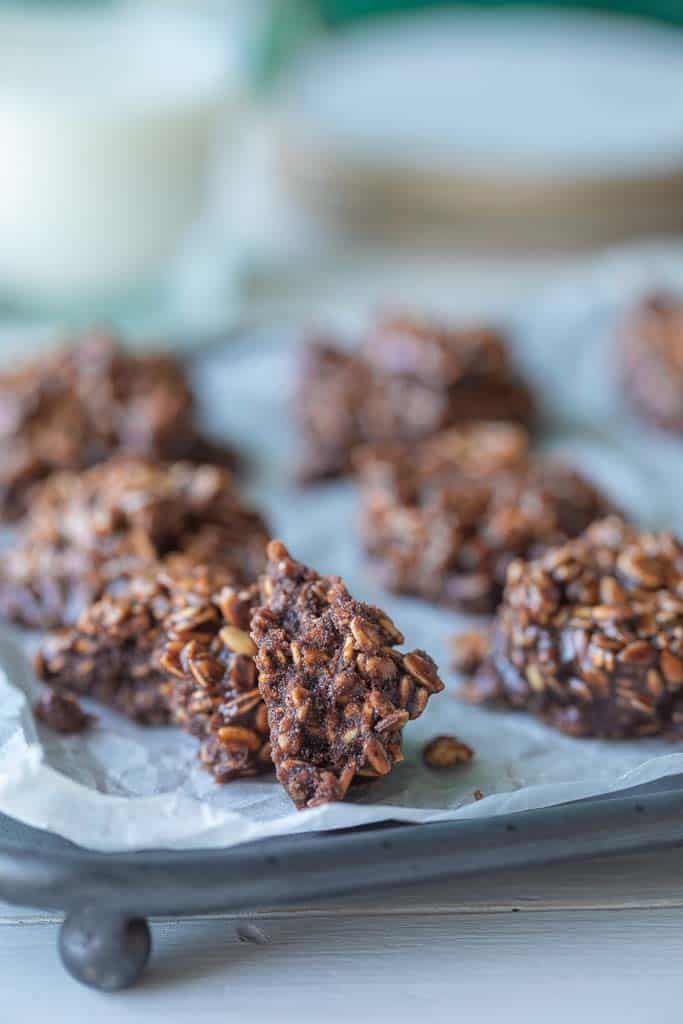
[0,457,267,627]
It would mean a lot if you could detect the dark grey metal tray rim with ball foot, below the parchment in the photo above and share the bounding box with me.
[0,323,683,990]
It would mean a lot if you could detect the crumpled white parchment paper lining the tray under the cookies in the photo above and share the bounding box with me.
[0,243,683,851]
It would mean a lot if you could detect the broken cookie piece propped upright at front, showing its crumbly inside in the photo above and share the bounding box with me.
[251,541,443,808]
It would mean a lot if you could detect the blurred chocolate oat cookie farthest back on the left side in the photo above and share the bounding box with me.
[0,334,234,519]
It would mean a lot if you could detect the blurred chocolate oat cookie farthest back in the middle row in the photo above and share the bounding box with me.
[295,315,533,480]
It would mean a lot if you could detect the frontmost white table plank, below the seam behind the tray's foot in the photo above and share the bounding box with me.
[0,908,683,1024]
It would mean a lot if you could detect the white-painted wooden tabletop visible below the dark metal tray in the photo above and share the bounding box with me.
[0,848,683,1024]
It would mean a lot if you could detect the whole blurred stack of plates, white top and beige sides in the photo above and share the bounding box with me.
[274,9,683,241]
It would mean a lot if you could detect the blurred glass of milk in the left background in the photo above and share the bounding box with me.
[0,3,242,309]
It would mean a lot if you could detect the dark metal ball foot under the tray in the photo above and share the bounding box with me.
[59,907,152,992]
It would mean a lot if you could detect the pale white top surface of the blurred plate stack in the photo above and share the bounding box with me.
[284,10,683,176]
